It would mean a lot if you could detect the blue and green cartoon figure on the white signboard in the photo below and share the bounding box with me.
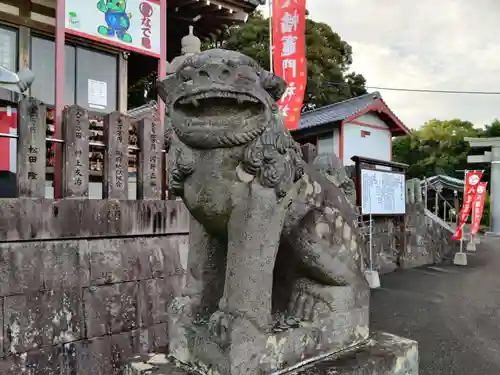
[97,0,132,43]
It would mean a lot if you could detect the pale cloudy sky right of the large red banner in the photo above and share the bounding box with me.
[264,0,500,128]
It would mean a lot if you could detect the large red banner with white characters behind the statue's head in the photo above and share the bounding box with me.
[272,0,307,130]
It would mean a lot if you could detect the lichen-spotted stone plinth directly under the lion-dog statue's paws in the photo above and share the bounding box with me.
[178,307,369,375]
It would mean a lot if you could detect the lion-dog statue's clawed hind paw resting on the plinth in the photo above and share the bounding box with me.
[288,279,335,321]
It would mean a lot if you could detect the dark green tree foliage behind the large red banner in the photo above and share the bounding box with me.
[203,11,366,110]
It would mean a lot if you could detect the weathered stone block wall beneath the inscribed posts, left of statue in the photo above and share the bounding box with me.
[0,199,189,375]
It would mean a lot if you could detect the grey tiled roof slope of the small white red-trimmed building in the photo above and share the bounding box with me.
[299,92,381,129]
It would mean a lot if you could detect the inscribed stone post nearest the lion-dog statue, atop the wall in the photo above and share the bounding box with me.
[137,118,163,199]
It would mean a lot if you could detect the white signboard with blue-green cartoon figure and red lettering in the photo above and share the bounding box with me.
[65,0,161,57]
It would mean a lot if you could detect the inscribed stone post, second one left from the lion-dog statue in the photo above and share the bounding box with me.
[102,112,130,200]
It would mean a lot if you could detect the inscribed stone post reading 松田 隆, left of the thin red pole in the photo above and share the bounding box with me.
[17,98,46,198]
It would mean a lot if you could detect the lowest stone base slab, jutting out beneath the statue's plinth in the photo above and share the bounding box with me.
[123,333,418,375]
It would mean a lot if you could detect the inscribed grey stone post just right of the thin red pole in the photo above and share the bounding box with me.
[62,105,89,198]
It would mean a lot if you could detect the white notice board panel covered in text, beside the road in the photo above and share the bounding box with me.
[361,169,406,215]
